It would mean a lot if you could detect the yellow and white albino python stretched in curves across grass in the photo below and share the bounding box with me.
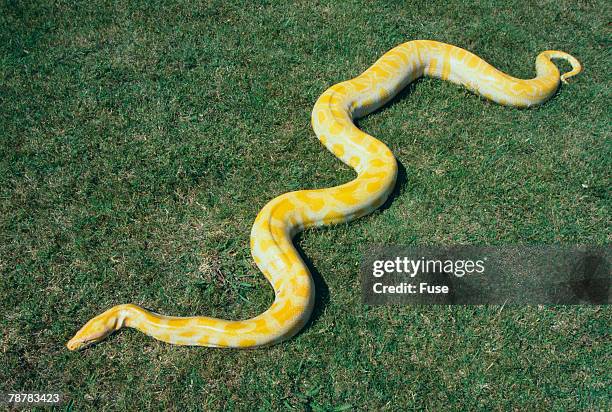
[67,40,581,350]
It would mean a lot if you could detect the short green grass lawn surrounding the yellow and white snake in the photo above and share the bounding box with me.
[0,0,612,411]
